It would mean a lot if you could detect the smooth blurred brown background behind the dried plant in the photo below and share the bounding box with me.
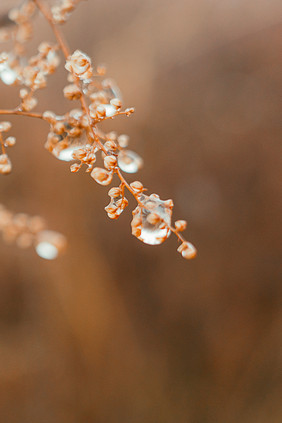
[0,0,282,423]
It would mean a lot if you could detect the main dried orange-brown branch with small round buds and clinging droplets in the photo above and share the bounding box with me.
[0,0,196,259]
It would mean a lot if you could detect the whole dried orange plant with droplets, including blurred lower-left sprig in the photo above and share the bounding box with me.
[0,0,196,259]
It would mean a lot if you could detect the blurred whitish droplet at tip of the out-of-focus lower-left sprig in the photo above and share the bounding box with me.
[35,231,66,260]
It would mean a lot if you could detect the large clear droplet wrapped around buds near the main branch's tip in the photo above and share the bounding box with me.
[131,194,172,245]
